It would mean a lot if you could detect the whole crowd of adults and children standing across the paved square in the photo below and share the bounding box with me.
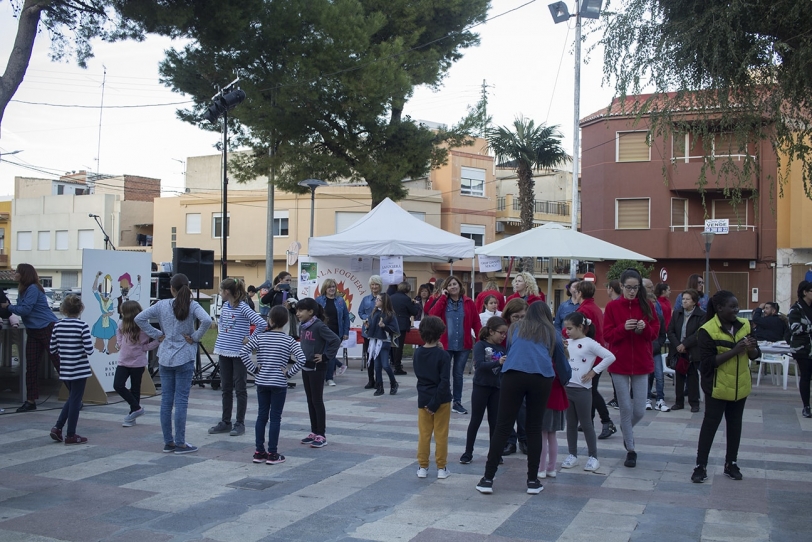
[6,264,812,494]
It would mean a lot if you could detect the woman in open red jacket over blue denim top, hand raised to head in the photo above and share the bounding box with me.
[430,275,482,414]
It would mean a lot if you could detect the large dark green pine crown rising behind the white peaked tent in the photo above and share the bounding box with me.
[135,0,489,205]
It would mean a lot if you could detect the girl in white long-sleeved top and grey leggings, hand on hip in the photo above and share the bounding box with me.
[561,312,615,471]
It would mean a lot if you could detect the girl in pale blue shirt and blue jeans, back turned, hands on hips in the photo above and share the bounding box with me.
[135,273,211,454]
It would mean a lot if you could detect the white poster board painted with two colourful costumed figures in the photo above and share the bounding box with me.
[82,249,152,392]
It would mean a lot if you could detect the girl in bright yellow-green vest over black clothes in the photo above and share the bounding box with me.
[691,290,761,484]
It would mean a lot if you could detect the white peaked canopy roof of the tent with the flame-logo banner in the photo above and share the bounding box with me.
[308,198,474,262]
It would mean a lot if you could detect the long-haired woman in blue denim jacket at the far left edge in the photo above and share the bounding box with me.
[1,263,59,412]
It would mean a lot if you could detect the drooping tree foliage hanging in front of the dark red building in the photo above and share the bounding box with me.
[601,0,812,197]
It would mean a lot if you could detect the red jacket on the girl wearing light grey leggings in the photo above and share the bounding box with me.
[603,297,660,375]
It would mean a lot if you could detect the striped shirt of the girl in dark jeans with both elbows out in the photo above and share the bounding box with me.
[240,331,306,388]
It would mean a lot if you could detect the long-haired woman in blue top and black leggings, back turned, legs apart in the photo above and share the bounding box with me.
[476,303,570,495]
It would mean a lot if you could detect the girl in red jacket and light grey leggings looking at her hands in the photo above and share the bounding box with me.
[603,269,660,468]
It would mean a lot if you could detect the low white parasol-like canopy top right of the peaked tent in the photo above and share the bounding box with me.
[476,222,655,262]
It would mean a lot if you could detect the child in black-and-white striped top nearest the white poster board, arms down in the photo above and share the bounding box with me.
[50,295,93,444]
